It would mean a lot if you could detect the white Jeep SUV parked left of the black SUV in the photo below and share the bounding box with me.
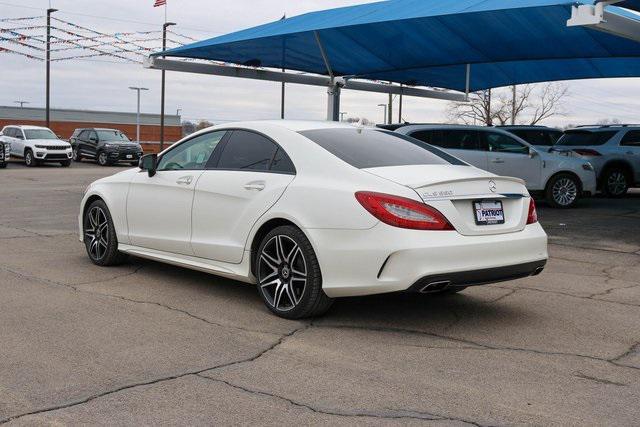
[0,126,73,167]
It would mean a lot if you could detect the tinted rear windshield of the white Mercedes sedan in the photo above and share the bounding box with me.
[300,128,467,169]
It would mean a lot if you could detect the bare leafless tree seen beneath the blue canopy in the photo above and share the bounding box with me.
[448,83,569,126]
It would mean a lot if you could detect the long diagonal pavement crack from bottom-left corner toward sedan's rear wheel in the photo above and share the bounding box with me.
[0,323,311,425]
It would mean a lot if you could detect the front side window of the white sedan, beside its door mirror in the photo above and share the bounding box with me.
[158,131,226,170]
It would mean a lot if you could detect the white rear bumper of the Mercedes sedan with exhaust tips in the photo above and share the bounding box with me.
[304,223,548,297]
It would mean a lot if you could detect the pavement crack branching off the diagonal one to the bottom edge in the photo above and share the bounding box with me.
[196,374,480,426]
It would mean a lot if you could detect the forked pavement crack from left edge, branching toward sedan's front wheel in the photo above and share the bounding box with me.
[0,266,278,335]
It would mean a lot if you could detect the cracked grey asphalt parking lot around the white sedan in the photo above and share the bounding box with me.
[0,163,640,426]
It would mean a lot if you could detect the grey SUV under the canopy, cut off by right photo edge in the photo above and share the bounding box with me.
[553,125,640,197]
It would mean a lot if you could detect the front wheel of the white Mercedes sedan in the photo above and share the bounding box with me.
[82,200,127,267]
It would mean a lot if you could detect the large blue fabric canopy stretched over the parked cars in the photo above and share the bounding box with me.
[161,0,640,91]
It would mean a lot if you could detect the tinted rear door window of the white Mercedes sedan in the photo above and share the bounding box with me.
[217,130,278,171]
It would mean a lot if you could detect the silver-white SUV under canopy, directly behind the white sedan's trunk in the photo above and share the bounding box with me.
[396,125,596,208]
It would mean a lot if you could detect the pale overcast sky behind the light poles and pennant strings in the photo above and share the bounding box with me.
[0,0,640,126]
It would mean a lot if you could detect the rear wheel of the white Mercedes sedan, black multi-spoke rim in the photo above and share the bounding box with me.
[255,225,333,319]
